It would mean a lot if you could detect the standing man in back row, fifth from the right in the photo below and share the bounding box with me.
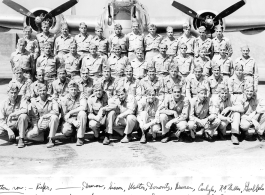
[144,24,163,62]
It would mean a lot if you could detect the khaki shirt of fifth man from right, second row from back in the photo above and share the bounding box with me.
[151,54,173,77]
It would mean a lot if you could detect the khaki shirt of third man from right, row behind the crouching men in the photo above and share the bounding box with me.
[186,74,210,97]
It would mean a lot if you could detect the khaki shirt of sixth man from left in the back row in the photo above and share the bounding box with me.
[109,33,129,53]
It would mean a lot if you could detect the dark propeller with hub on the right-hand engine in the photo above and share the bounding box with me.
[171,0,246,31]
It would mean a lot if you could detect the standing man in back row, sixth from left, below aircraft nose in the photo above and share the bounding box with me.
[109,23,129,57]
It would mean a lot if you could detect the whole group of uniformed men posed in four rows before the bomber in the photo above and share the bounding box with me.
[0,21,265,148]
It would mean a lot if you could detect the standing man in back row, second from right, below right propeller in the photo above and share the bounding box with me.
[194,26,213,58]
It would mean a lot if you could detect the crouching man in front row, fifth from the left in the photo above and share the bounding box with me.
[106,88,139,143]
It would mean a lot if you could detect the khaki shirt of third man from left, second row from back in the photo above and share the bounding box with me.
[62,53,82,74]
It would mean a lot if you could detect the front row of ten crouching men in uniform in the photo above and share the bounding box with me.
[0,64,265,148]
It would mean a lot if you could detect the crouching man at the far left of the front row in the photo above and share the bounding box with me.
[0,83,28,148]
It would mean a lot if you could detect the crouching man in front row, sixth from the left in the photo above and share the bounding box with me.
[137,88,161,143]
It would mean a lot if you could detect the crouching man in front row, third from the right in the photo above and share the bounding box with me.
[188,85,221,141]
